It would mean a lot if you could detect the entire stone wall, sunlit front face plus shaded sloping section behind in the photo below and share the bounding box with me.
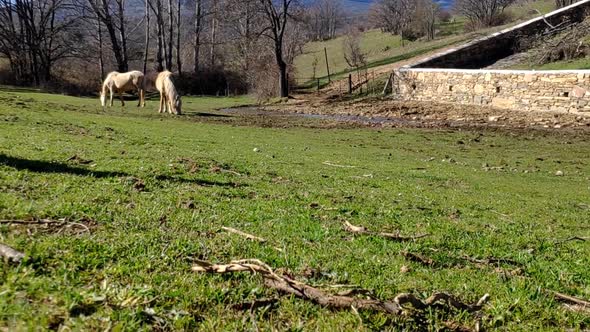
[393,0,590,115]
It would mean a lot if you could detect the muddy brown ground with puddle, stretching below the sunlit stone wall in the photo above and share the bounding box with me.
[195,96,590,135]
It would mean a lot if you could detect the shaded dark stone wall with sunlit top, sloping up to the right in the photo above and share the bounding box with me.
[412,0,590,69]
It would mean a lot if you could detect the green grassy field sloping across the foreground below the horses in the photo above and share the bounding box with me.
[0,89,590,331]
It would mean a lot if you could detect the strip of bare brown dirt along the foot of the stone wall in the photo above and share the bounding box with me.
[254,98,590,132]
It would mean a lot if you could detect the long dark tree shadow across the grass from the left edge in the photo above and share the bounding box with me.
[0,153,244,188]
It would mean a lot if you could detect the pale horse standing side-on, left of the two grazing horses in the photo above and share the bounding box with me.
[100,70,145,107]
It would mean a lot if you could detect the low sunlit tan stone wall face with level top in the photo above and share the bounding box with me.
[393,68,590,114]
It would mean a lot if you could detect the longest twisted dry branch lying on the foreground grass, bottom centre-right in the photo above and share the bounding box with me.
[192,259,489,315]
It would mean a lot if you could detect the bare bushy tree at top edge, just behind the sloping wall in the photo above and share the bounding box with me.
[455,0,516,27]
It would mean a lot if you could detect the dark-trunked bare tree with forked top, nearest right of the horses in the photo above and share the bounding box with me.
[258,0,296,97]
